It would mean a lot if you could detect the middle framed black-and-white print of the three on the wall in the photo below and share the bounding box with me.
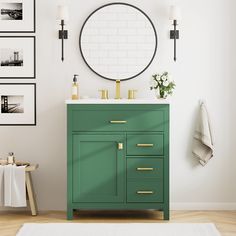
[0,36,35,79]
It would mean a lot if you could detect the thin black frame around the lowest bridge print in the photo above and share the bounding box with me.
[0,83,37,126]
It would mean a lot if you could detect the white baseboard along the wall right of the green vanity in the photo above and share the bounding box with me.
[170,202,236,211]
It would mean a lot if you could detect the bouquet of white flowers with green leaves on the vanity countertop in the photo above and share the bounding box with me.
[150,72,176,98]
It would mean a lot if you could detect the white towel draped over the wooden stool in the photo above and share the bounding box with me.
[4,165,26,207]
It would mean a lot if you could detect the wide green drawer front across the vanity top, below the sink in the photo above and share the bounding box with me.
[71,110,165,131]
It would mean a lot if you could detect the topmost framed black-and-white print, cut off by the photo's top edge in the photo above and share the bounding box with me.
[0,0,35,33]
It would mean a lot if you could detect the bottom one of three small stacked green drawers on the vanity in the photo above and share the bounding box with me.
[127,180,163,202]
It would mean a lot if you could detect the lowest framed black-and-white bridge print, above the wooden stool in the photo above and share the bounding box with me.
[0,83,36,126]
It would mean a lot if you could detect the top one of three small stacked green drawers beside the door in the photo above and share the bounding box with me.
[127,133,164,156]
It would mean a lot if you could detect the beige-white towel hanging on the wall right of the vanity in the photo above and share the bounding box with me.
[192,103,214,166]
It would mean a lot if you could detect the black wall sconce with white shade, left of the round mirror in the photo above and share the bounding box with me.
[57,6,69,61]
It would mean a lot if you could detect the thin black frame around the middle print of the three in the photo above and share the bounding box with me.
[0,35,36,80]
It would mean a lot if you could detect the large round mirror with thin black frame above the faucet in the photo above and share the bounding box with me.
[79,3,157,80]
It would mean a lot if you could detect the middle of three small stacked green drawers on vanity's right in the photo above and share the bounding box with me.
[127,157,163,179]
